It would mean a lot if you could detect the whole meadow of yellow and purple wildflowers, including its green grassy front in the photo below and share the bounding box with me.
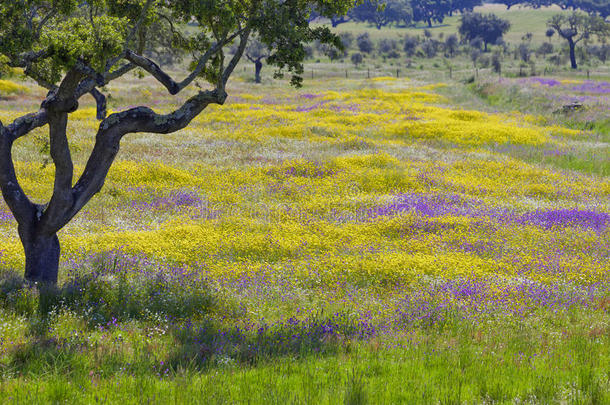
[0,77,610,403]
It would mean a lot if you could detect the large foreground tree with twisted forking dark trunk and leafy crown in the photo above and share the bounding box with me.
[0,0,354,283]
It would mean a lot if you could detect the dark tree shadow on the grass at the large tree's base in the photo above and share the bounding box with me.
[0,264,376,376]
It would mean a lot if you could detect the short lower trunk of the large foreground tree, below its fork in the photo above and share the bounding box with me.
[20,227,61,284]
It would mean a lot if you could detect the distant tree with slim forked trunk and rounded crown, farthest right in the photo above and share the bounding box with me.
[547,12,610,69]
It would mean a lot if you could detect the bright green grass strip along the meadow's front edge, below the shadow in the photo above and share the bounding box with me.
[0,304,610,404]
